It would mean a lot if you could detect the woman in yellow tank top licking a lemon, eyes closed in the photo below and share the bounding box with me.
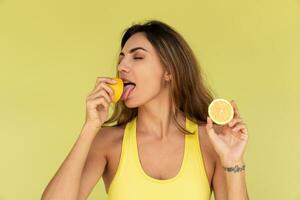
[42,20,248,200]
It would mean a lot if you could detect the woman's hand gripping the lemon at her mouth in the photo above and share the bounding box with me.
[85,77,116,128]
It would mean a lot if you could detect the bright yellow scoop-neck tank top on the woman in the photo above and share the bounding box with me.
[108,117,211,200]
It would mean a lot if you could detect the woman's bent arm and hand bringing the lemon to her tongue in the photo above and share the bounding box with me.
[42,77,114,200]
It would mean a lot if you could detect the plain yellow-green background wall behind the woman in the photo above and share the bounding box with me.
[0,0,300,200]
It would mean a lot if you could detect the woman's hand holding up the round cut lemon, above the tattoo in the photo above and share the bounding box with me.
[206,100,248,165]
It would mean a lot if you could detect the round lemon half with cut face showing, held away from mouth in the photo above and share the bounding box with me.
[208,98,234,125]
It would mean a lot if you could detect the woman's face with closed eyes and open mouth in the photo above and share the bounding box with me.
[118,33,167,108]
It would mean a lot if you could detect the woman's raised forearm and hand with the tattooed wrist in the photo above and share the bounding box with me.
[206,100,249,200]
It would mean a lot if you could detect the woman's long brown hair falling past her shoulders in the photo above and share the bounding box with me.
[103,20,213,134]
